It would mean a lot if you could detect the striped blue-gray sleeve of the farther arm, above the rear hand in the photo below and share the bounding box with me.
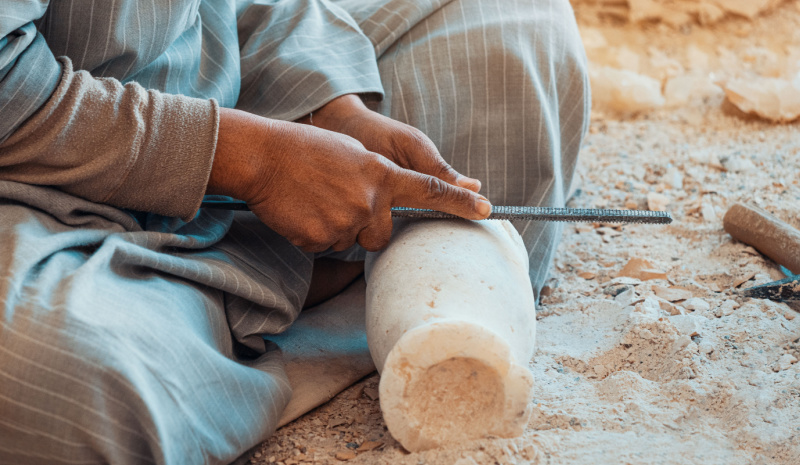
[237,0,383,120]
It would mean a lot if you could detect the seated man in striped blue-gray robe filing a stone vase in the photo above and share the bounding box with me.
[0,0,589,464]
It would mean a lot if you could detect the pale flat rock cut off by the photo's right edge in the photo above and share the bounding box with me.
[717,74,800,123]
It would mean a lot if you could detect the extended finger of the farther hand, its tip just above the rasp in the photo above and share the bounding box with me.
[398,126,481,192]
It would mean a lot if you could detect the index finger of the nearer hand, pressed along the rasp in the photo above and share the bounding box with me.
[389,168,492,220]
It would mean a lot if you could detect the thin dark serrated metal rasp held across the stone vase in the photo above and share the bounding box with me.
[200,200,672,224]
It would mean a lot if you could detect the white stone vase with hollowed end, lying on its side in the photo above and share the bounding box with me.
[366,220,536,451]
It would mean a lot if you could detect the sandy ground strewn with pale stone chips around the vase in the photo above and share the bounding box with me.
[251,2,800,465]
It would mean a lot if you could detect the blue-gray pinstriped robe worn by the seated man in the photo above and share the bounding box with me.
[0,0,589,464]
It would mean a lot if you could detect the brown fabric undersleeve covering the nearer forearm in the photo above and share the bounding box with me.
[0,59,218,219]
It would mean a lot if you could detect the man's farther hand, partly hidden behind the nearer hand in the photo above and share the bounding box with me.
[298,94,481,192]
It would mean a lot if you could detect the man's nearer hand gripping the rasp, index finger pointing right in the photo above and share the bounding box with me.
[207,108,491,252]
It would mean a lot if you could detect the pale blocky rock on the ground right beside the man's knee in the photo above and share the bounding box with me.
[589,66,664,113]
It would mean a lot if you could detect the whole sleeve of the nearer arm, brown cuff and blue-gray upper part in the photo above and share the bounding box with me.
[0,0,219,220]
